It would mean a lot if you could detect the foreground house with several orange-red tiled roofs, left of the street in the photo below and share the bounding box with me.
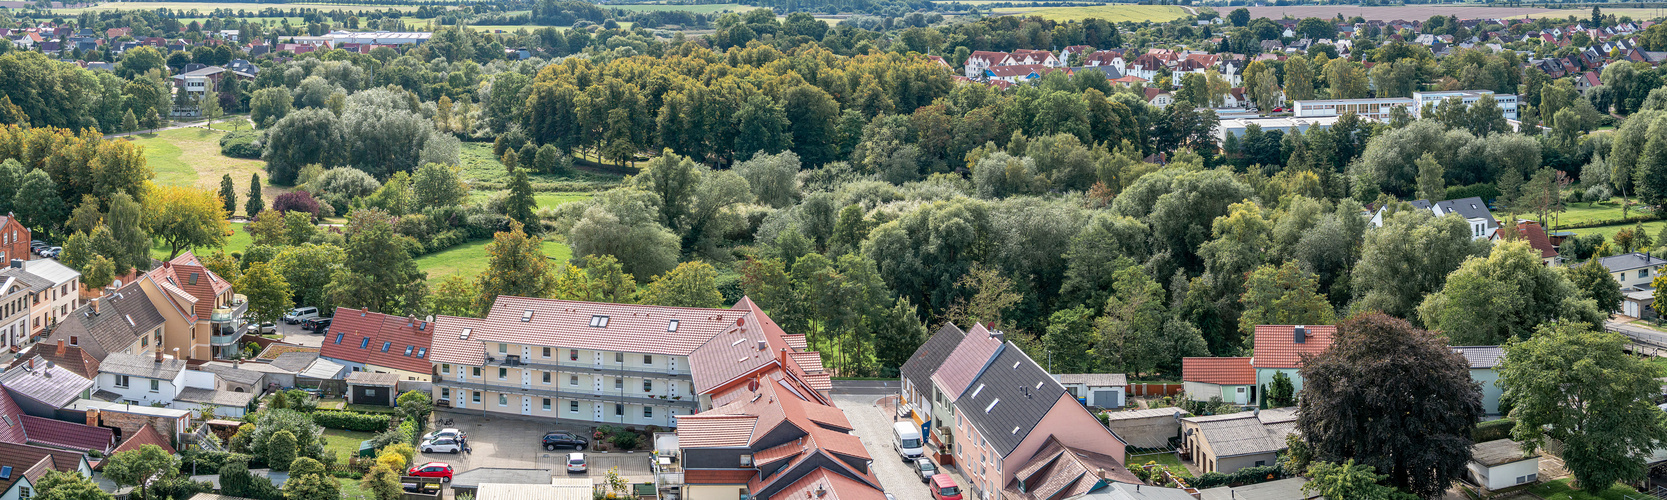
[677,378,885,500]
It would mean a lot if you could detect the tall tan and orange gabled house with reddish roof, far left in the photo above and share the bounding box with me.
[138,252,248,360]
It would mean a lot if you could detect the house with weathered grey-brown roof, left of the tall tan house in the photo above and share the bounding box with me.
[47,283,163,362]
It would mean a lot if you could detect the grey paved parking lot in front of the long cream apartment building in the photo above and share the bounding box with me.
[415,412,656,483]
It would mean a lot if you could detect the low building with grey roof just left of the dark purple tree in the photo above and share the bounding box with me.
[1180,408,1297,473]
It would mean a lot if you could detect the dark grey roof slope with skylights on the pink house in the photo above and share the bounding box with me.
[955,342,1065,457]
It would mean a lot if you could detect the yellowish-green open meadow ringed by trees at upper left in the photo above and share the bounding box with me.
[127,127,290,212]
